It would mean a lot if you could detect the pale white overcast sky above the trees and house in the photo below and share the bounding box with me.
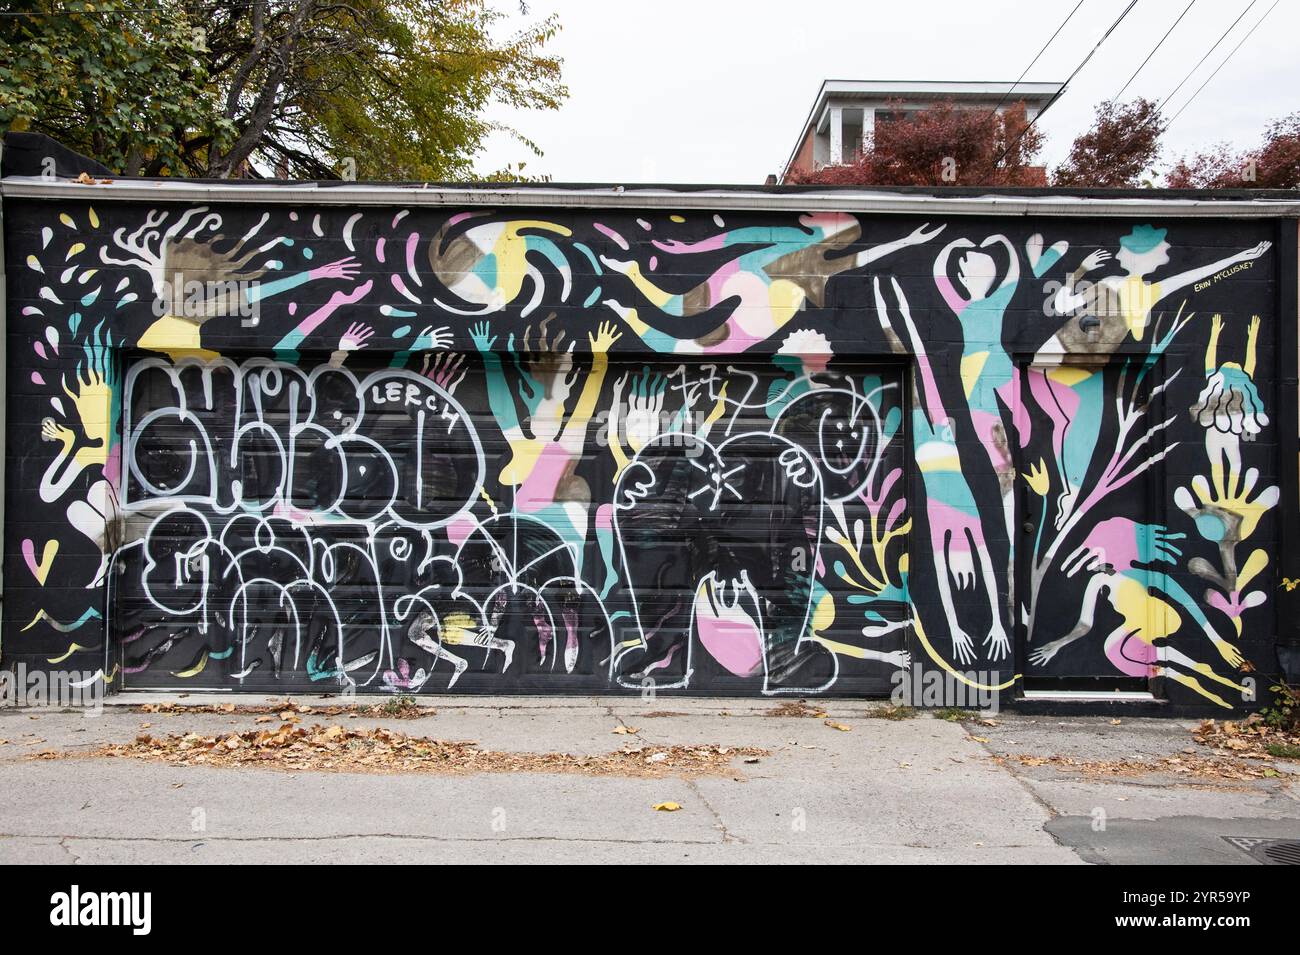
[477,0,1300,183]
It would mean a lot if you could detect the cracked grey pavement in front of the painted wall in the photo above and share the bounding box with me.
[0,694,1300,865]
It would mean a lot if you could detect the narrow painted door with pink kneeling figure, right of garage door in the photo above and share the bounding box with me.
[1015,356,1177,690]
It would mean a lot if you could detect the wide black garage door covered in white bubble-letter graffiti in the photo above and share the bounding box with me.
[109,343,909,695]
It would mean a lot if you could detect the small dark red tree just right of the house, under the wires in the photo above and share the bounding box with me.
[1052,99,1165,188]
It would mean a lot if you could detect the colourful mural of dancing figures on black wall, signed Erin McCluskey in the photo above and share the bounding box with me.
[4,194,1279,707]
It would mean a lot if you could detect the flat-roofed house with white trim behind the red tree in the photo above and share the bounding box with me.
[779,79,1065,182]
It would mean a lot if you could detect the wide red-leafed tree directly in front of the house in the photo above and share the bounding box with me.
[787,101,1047,186]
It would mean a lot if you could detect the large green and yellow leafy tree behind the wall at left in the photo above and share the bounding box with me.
[0,0,567,179]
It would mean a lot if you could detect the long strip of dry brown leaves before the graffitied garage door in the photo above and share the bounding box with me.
[73,722,768,777]
